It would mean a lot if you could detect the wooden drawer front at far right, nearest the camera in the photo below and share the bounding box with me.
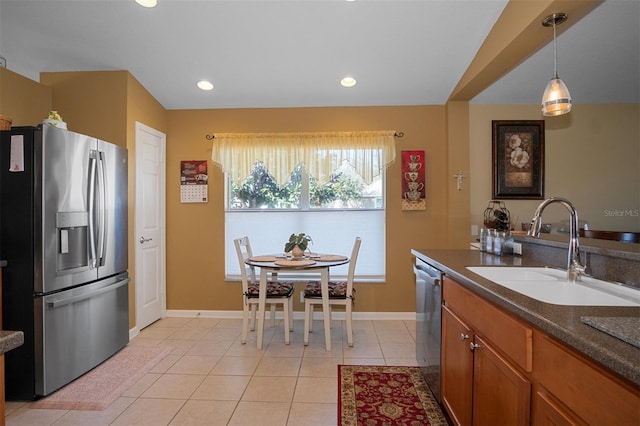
[534,331,640,426]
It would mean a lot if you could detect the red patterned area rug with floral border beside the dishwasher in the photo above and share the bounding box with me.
[338,365,447,426]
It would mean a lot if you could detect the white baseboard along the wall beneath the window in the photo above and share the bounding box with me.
[166,310,416,321]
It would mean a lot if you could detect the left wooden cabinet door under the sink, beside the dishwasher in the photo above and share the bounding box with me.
[441,306,473,426]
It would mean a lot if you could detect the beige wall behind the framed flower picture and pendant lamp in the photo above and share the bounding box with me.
[469,104,640,232]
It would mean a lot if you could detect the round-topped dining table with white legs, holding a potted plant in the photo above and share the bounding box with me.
[245,253,349,351]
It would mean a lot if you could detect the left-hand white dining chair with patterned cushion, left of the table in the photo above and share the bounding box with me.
[233,237,294,345]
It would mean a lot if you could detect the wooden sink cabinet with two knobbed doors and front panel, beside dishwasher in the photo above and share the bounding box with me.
[442,277,532,425]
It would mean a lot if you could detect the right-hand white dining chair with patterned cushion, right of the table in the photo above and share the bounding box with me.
[304,237,362,346]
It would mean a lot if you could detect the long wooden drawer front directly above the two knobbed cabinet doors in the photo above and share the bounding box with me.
[443,276,533,373]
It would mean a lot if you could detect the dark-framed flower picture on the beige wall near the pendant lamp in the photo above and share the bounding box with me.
[491,120,544,200]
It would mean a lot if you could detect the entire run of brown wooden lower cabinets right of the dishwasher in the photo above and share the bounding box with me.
[442,276,640,426]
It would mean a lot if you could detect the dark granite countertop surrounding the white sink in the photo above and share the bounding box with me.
[411,249,640,386]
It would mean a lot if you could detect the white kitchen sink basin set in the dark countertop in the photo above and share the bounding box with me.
[467,266,640,306]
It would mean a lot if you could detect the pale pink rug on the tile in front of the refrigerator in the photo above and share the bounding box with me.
[31,345,173,411]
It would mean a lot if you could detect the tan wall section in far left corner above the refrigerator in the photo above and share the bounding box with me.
[0,68,52,126]
